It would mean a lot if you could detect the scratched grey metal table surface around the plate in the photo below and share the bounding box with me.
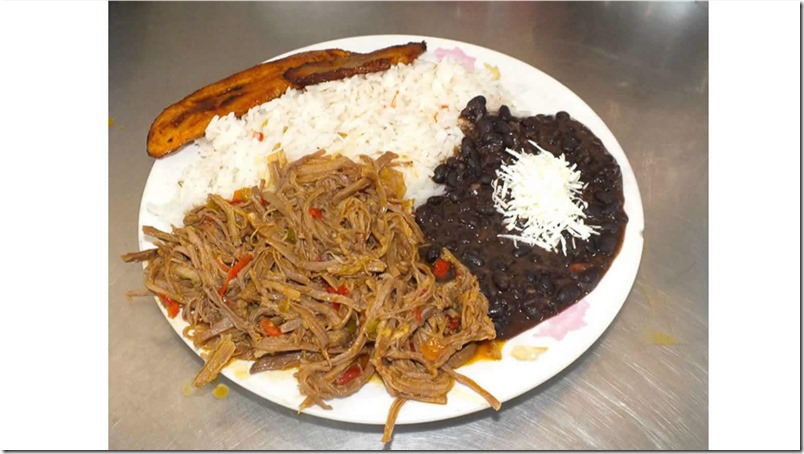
[109,2,708,450]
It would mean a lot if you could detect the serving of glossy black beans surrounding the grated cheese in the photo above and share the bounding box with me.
[416,100,628,338]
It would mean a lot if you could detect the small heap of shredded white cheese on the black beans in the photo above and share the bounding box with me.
[491,141,599,255]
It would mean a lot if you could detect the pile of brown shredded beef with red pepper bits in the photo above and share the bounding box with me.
[124,151,499,442]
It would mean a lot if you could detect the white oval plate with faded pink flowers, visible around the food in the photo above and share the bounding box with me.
[139,35,644,424]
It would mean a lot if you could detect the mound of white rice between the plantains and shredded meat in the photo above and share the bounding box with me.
[149,58,510,225]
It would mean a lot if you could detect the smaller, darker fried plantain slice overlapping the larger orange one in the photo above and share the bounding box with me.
[284,41,427,86]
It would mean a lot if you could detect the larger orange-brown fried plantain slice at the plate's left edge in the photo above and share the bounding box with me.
[147,49,352,158]
